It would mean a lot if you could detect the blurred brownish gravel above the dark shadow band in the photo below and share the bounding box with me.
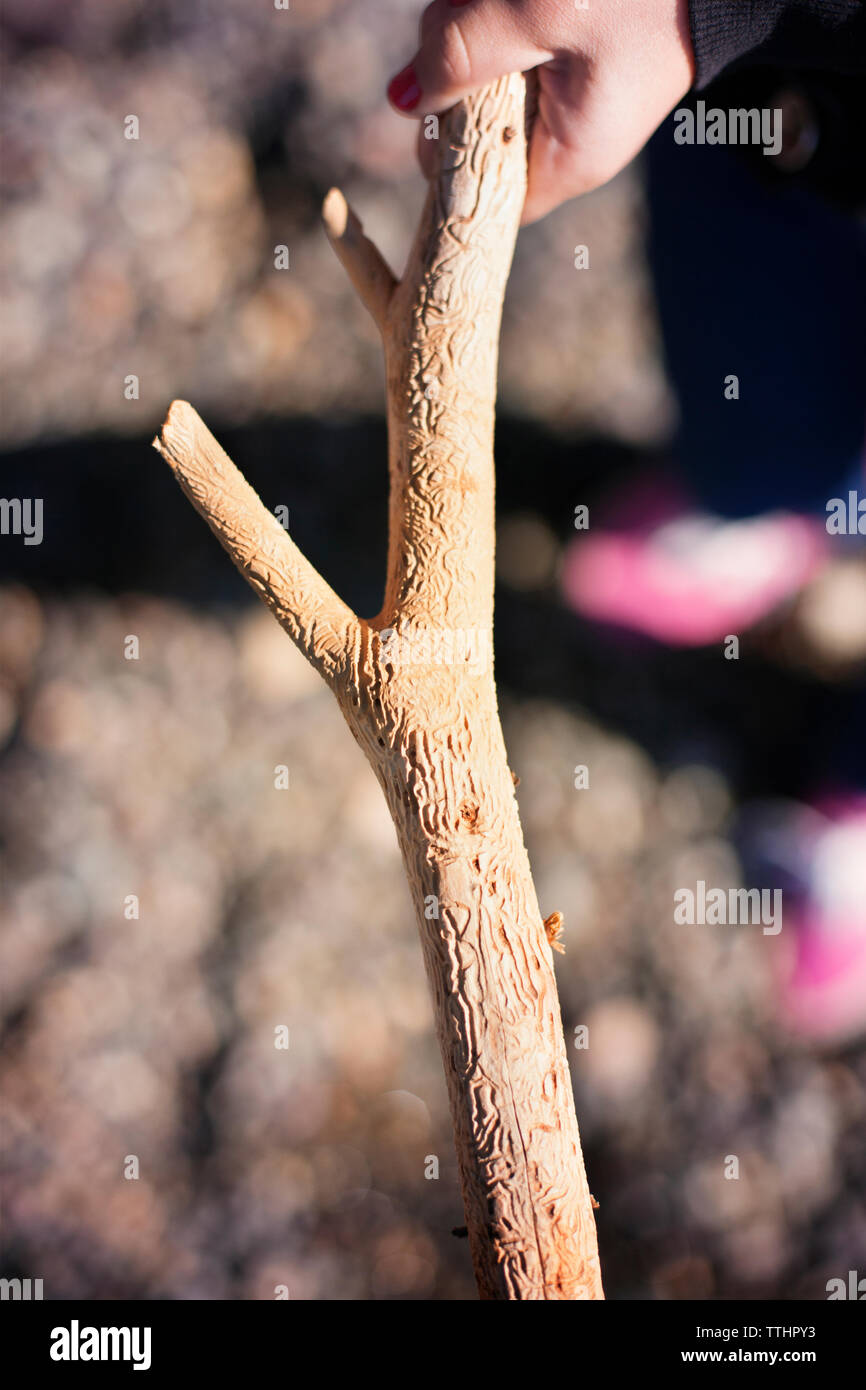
[0,0,670,442]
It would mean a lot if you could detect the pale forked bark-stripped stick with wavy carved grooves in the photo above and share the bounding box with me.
[154,76,603,1300]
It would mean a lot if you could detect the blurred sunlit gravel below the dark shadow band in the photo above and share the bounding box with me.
[0,588,866,1298]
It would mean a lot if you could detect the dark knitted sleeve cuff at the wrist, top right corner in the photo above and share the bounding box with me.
[688,0,866,88]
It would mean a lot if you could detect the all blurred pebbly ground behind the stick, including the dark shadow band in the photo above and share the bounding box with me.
[0,0,866,1300]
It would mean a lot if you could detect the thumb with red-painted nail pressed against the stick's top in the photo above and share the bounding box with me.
[388,0,553,115]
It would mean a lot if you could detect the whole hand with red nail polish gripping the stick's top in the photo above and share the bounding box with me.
[388,0,695,224]
